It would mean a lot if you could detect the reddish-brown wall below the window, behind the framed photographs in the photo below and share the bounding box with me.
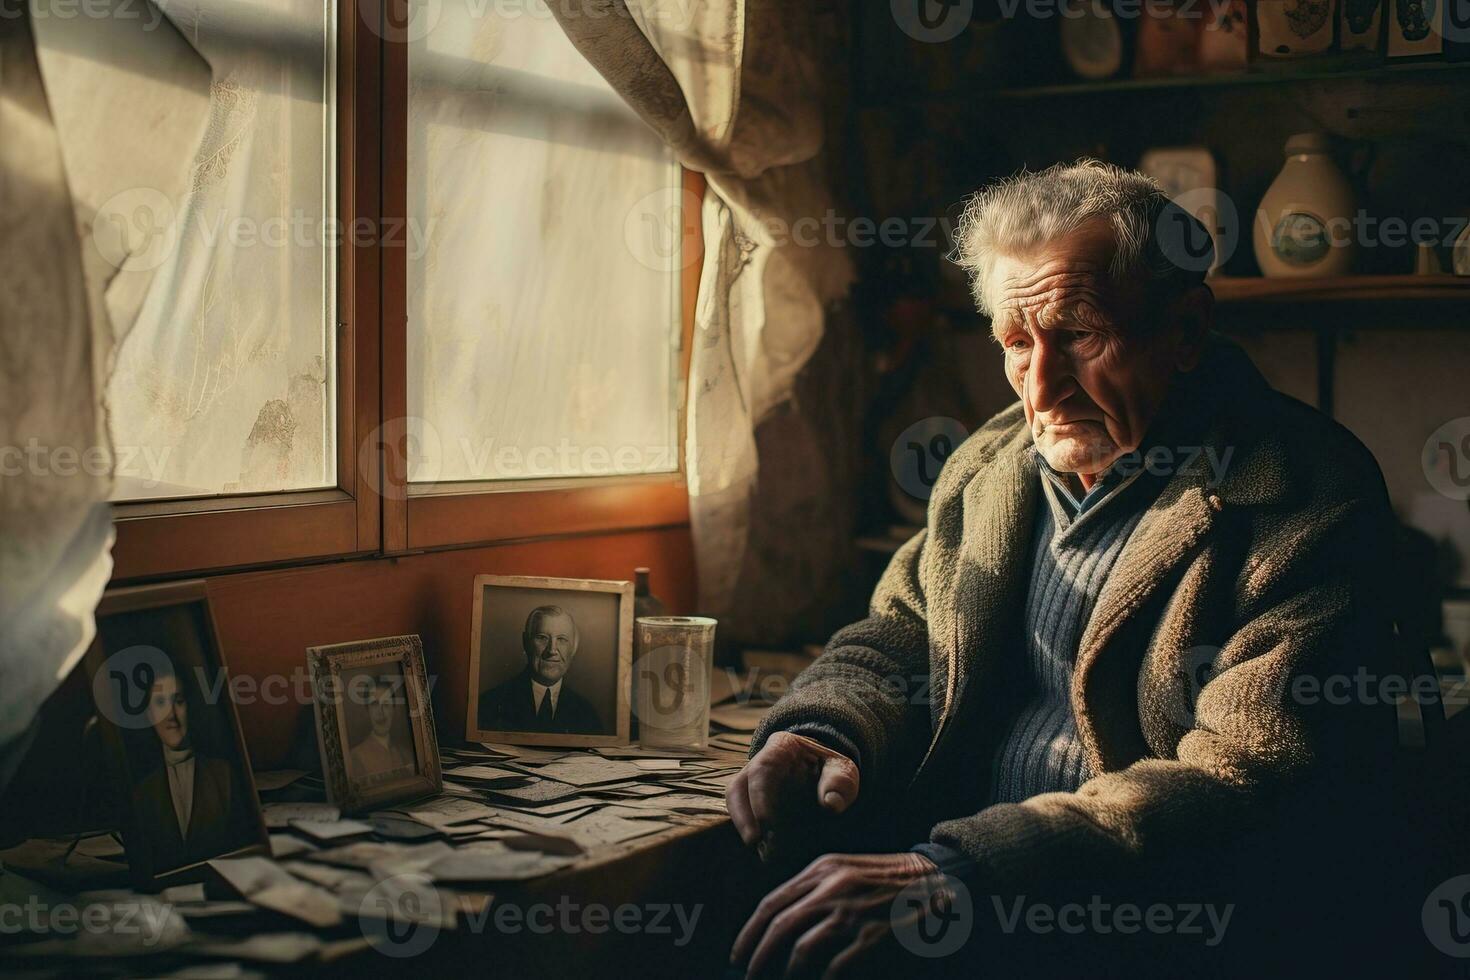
[0,526,697,842]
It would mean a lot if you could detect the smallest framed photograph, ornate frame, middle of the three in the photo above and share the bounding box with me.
[306,635,444,813]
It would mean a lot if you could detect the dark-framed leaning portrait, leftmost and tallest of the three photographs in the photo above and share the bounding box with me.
[85,582,270,887]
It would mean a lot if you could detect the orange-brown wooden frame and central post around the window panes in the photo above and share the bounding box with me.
[113,0,704,582]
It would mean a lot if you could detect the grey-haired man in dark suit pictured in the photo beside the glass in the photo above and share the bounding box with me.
[476,605,604,735]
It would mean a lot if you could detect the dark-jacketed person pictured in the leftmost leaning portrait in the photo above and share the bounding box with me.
[132,667,251,868]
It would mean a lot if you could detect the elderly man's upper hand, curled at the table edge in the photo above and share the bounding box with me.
[725,732,857,845]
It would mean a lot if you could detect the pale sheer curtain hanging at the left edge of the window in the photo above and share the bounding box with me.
[0,0,209,785]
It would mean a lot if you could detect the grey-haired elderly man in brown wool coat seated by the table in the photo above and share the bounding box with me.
[728,162,1393,976]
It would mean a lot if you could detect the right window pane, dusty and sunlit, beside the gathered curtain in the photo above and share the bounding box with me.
[407,0,681,483]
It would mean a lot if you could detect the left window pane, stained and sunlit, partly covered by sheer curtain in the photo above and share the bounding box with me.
[107,0,337,500]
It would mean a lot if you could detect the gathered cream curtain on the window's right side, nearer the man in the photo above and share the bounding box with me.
[550,0,853,614]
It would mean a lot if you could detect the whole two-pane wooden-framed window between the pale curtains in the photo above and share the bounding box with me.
[87,0,703,580]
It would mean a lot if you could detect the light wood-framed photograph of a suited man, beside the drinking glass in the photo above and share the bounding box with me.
[466,574,634,746]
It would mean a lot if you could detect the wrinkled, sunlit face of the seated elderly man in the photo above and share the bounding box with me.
[986,220,1192,483]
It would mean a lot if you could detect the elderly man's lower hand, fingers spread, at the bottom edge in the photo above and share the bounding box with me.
[731,852,938,979]
